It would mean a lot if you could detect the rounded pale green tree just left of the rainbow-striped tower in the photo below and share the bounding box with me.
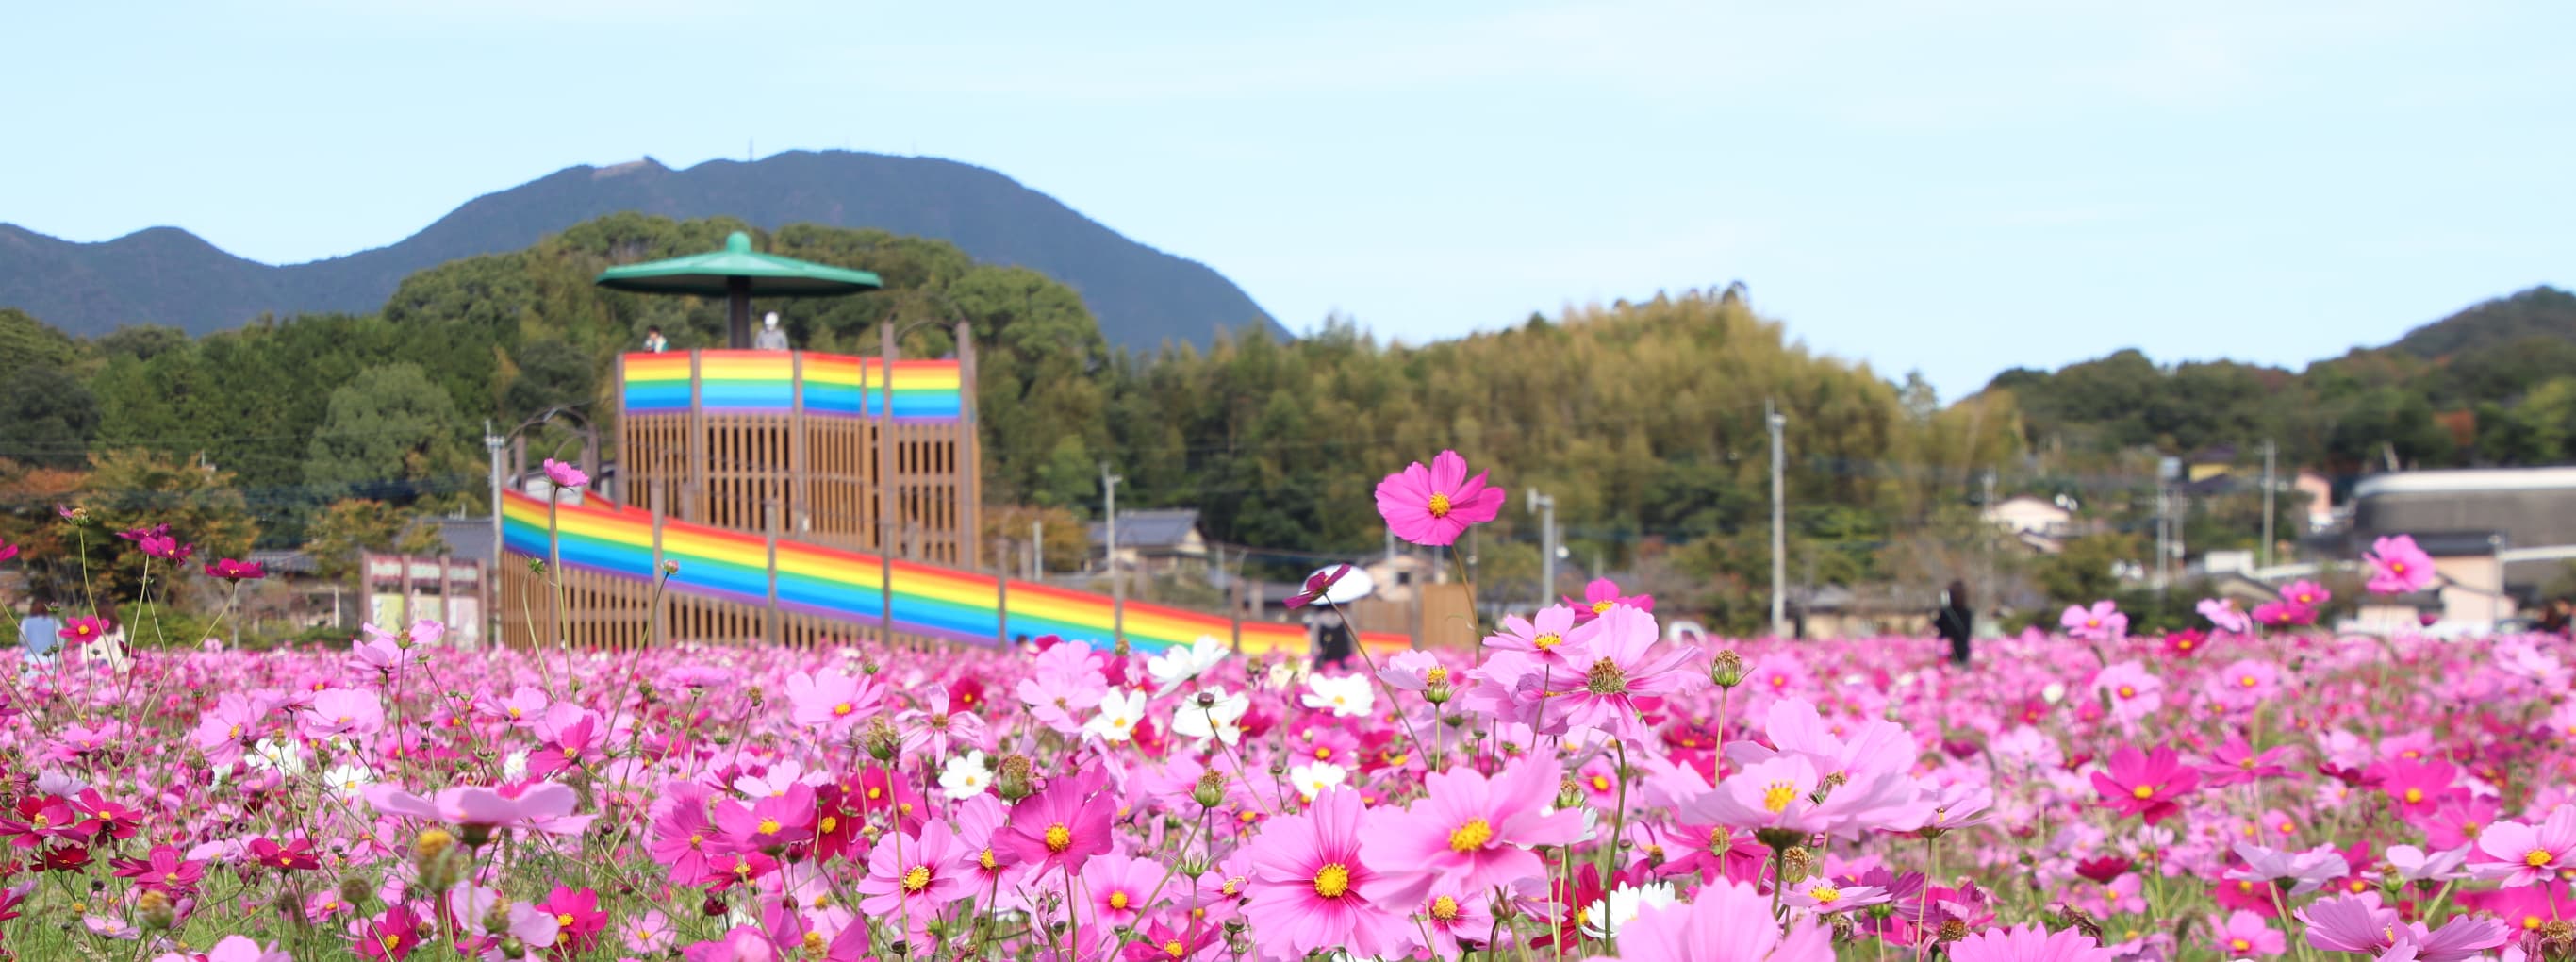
[304,364,474,503]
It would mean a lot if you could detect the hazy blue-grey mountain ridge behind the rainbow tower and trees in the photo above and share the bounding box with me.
[0,150,1283,351]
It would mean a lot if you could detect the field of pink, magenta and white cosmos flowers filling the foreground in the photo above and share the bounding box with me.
[0,454,2576,962]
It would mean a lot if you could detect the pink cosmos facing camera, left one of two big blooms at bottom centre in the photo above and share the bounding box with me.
[1245,789,1404,959]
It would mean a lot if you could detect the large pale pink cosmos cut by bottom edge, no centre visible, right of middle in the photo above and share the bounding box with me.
[1618,879,1834,962]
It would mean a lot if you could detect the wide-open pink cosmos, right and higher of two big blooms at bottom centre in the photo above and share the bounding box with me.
[1360,758,1584,905]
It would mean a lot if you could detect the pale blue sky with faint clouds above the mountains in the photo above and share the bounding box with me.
[0,0,2576,397]
